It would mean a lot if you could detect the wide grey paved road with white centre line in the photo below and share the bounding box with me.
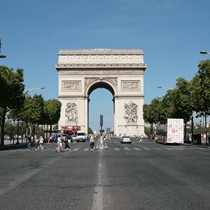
[0,139,210,210]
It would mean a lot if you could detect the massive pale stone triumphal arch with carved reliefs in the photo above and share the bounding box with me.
[55,49,147,135]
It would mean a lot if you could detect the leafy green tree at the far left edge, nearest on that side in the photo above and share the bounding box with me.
[0,66,25,146]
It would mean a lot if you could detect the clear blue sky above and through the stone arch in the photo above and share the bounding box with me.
[0,0,210,130]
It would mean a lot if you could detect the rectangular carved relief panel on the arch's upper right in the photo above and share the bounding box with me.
[121,80,141,92]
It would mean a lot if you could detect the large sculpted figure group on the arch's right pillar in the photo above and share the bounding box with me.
[124,101,138,123]
